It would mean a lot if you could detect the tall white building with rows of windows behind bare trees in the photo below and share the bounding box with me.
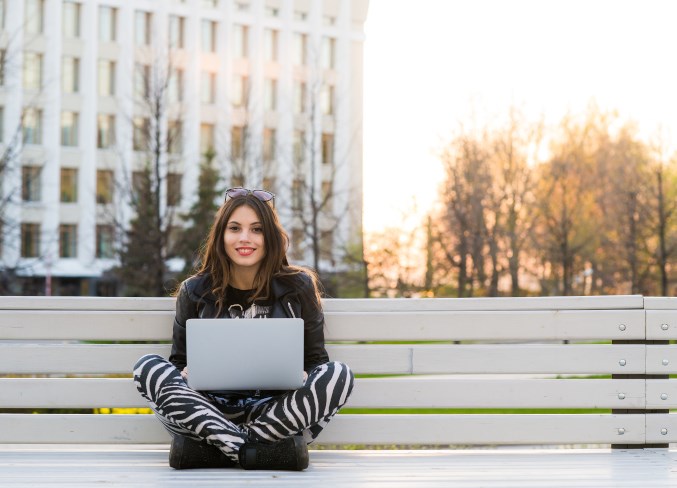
[0,0,368,294]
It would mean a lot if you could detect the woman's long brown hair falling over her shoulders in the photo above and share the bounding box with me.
[197,194,320,313]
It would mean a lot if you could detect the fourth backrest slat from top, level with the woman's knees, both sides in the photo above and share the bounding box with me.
[0,378,645,409]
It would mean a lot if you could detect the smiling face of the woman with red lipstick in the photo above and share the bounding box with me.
[223,205,266,272]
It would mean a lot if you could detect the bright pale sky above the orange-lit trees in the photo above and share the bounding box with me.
[364,0,677,232]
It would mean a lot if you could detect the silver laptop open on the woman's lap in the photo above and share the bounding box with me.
[186,318,303,390]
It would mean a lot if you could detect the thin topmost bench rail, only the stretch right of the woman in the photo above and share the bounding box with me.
[324,295,644,312]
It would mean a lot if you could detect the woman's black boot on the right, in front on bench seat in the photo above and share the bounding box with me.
[238,436,308,471]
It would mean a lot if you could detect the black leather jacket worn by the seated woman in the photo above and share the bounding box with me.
[169,273,329,372]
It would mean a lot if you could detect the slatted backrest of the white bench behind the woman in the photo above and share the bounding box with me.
[0,296,677,447]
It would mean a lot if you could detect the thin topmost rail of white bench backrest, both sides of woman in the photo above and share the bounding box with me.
[0,295,644,312]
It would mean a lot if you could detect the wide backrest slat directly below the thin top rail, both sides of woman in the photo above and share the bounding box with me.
[0,310,645,341]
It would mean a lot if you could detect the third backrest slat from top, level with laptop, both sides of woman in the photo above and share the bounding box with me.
[0,343,648,374]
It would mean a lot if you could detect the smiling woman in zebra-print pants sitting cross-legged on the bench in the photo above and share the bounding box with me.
[134,188,354,470]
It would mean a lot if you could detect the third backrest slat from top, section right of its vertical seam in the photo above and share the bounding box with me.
[412,344,645,374]
